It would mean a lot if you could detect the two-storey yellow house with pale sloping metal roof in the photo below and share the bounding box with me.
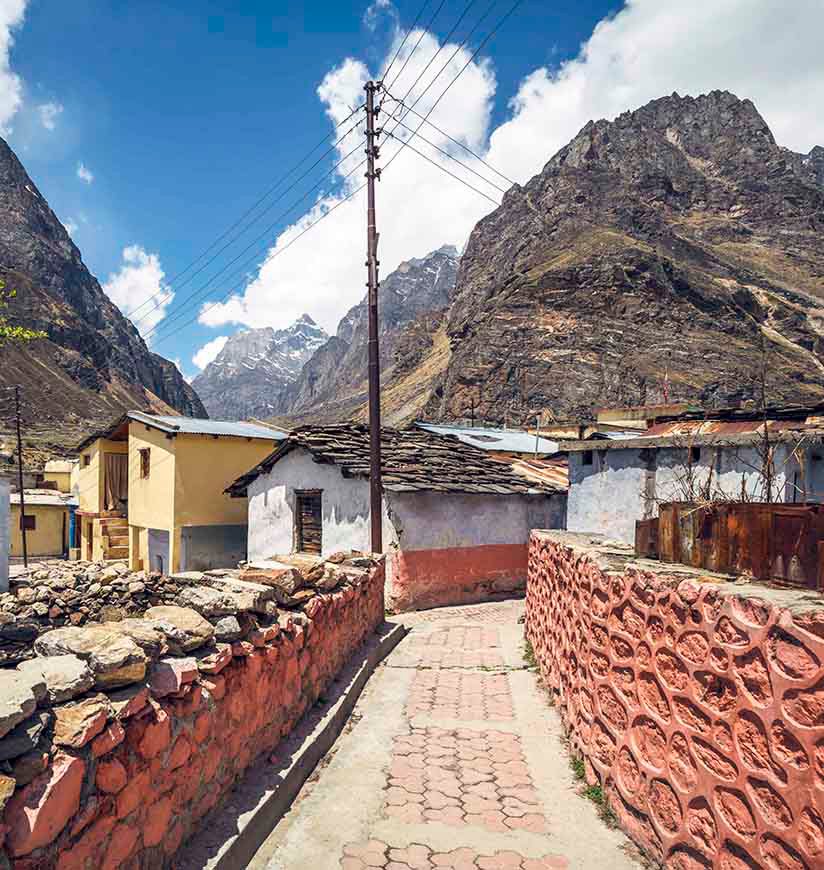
[78,411,286,573]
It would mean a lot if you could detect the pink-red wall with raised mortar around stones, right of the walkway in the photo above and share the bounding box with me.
[526,532,824,870]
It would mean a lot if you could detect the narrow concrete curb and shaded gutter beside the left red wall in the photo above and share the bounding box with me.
[173,622,409,870]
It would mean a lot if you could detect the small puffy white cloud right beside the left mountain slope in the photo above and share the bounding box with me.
[103,245,174,344]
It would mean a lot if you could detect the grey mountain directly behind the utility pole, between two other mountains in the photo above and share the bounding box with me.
[276,245,459,421]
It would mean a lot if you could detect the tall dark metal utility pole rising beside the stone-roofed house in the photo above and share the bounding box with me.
[364,81,383,553]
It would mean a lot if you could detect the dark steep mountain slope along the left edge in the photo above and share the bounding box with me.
[0,139,206,460]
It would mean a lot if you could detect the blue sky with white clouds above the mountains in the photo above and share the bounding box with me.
[0,0,824,375]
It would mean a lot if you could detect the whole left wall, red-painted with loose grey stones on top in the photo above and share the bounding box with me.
[0,554,384,870]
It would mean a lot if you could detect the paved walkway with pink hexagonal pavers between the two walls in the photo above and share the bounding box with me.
[249,602,639,870]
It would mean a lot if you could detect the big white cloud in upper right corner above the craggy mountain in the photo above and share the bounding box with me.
[489,0,824,180]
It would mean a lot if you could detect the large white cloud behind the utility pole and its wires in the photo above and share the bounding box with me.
[200,27,500,331]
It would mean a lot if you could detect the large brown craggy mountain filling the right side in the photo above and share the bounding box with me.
[384,91,824,421]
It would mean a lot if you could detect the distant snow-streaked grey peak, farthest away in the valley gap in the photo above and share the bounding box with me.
[192,314,329,420]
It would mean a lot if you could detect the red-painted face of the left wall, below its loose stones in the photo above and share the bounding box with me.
[0,563,384,870]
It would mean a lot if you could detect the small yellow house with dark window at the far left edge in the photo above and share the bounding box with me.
[10,489,75,559]
